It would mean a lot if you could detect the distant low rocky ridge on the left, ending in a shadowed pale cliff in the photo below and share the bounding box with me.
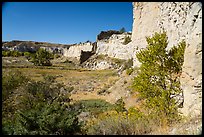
[2,40,96,63]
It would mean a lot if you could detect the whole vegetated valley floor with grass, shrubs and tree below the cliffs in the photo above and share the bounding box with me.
[2,32,200,135]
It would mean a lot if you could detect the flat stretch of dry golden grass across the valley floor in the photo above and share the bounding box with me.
[3,68,118,103]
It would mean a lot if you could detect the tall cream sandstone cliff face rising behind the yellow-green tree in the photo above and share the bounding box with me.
[130,2,202,116]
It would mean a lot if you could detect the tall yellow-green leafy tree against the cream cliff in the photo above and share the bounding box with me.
[133,32,186,123]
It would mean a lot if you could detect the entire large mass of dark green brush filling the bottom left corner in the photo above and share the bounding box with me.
[2,74,81,135]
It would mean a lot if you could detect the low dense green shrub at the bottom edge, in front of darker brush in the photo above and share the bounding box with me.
[11,101,80,135]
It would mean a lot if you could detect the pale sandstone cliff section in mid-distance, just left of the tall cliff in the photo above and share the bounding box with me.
[96,33,133,60]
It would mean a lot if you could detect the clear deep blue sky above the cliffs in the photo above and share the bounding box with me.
[2,2,133,44]
